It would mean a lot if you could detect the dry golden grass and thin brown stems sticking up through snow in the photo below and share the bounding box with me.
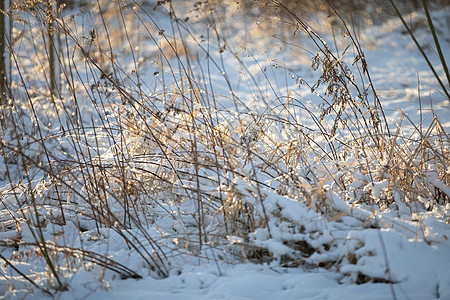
[0,0,450,292]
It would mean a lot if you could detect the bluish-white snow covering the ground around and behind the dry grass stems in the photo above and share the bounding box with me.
[0,1,450,299]
